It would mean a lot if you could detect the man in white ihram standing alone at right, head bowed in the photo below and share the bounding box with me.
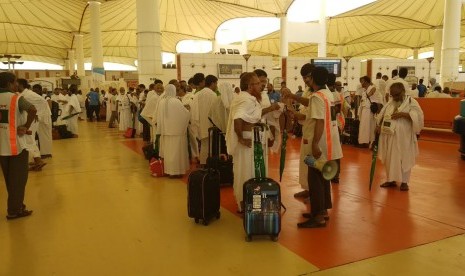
[377,83,424,191]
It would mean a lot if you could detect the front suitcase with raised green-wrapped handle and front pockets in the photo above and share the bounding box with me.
[243,125,282,241]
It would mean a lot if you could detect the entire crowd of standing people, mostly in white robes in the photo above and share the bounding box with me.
[0,61,423,225]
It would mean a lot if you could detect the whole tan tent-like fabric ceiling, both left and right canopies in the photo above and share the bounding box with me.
[0,0,465,64]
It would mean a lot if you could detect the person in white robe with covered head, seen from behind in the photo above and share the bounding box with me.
[157,84,190,177]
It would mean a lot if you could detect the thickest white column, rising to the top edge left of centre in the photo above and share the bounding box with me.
[136,0,163,86]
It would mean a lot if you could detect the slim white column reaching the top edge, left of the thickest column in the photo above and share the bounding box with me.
[89,1,105,86]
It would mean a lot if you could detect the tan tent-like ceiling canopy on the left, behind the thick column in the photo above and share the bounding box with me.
[0,0,292,64]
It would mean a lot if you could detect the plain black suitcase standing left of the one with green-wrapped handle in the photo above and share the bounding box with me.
[187,169,220,225]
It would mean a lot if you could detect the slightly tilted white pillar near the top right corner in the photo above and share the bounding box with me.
[436,0,462,85]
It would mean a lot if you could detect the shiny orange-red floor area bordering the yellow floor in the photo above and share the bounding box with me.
[122,130,465,269]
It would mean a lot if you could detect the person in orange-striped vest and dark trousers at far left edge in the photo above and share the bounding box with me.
[0,72,37,219]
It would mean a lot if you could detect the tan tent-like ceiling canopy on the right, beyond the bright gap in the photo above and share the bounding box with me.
[249,0,465,60]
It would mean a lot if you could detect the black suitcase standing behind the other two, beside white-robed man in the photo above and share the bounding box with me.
[207,126,234,186]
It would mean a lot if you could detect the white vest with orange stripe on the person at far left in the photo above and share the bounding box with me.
[0,92,24,156]
